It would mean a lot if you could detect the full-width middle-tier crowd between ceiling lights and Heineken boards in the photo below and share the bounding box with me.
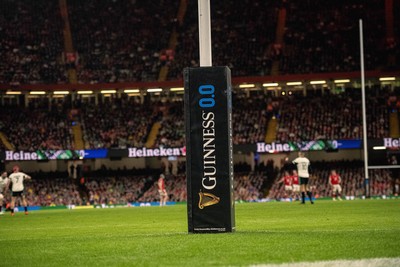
[0,87,398,150]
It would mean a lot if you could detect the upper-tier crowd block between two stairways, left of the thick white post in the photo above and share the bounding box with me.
[68,1,179,83]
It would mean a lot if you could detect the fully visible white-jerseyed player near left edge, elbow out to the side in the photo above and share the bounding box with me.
[9,166,31,216]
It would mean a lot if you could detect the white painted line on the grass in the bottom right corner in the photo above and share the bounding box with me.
[250,258,400,267]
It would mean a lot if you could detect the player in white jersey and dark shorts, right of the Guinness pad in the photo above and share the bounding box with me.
[293,152,314,204]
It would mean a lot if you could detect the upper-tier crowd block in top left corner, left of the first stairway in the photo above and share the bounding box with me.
[0,0,67,85]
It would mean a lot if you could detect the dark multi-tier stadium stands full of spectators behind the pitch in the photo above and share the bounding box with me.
[0,0,400,206]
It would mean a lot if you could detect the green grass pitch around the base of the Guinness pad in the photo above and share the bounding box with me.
[0,199,400,267]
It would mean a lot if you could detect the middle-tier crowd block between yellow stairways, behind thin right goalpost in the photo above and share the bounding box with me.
[276,88,389,142]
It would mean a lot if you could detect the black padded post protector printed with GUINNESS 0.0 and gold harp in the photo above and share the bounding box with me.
[184,67,235,233]
